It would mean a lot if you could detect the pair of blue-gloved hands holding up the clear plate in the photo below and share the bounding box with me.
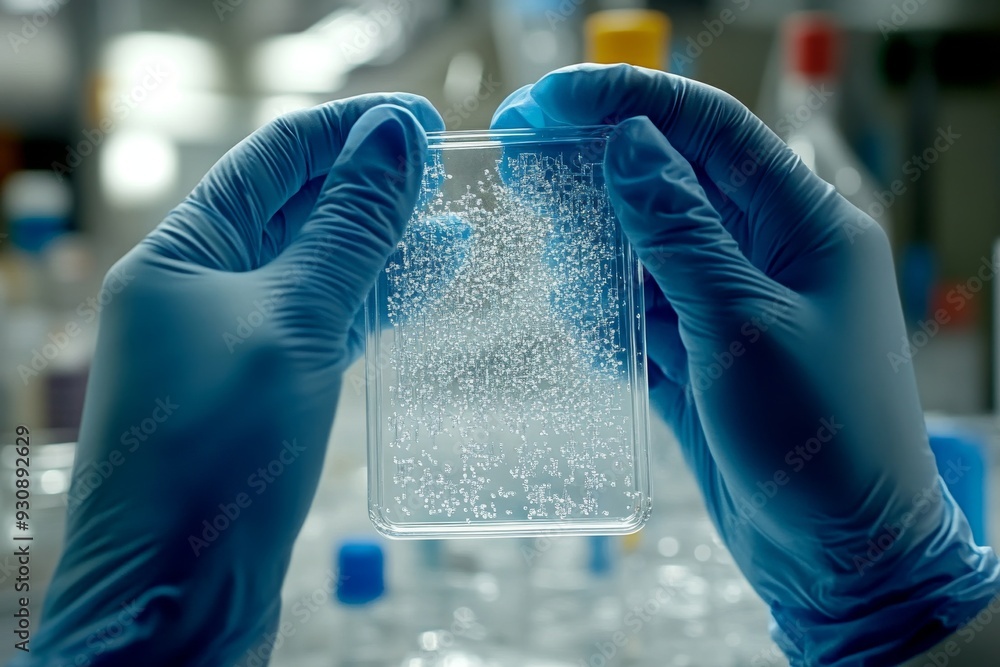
[25,65,1000,665]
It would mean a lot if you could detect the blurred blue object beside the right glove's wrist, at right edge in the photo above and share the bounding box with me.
[928,427,987,546]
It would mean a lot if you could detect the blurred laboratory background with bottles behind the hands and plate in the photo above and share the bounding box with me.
[0,0,1000,667]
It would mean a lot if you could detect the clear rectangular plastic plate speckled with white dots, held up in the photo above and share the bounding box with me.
[366,126,651,538]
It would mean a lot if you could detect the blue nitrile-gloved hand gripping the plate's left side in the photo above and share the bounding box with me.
[16,94,443,667]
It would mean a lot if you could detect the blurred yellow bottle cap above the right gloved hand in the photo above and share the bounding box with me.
[583,9,670,70]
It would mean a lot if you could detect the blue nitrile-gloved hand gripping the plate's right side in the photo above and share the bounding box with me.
[494,65,1000,666]
